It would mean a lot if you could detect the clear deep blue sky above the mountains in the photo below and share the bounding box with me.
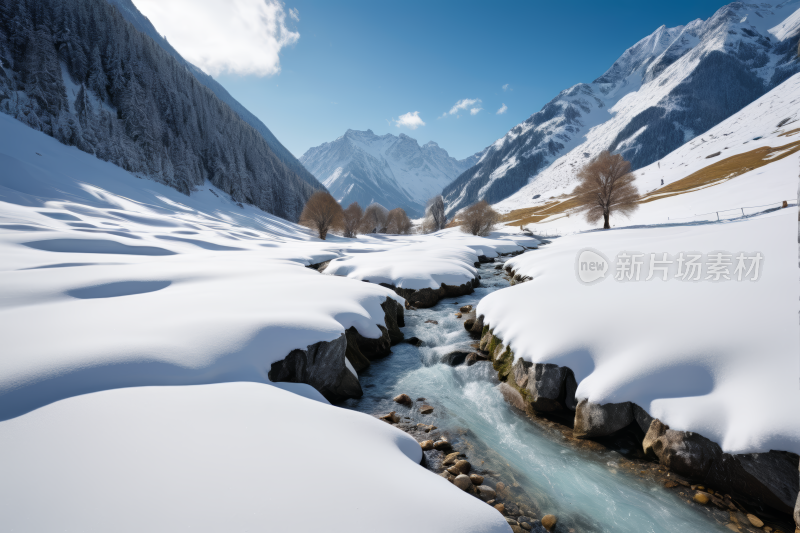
[134,0,724,158]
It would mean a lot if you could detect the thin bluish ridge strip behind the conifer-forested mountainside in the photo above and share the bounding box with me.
[107,0,322,189]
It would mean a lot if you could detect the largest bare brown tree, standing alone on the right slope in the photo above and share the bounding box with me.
[573,150,640,229]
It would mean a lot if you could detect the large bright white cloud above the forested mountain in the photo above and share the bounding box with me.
[133,0,300,76]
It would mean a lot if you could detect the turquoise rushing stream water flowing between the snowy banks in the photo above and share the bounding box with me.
[344,264,730,533]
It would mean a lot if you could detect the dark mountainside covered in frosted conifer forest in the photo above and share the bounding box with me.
[0,0,321,220]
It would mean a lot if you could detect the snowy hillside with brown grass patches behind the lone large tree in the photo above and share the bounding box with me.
[496,73,800,234]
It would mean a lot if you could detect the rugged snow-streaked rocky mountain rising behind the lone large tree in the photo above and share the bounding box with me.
[443,0,800,213]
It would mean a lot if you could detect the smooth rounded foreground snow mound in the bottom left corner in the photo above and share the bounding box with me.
[0,383,509,533]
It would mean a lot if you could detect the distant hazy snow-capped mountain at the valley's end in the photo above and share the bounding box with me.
[300,130,480,216]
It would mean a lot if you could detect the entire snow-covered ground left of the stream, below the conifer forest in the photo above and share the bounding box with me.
[0,115,513,533]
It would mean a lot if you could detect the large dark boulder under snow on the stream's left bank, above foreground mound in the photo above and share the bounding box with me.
[267,334,362,403]
